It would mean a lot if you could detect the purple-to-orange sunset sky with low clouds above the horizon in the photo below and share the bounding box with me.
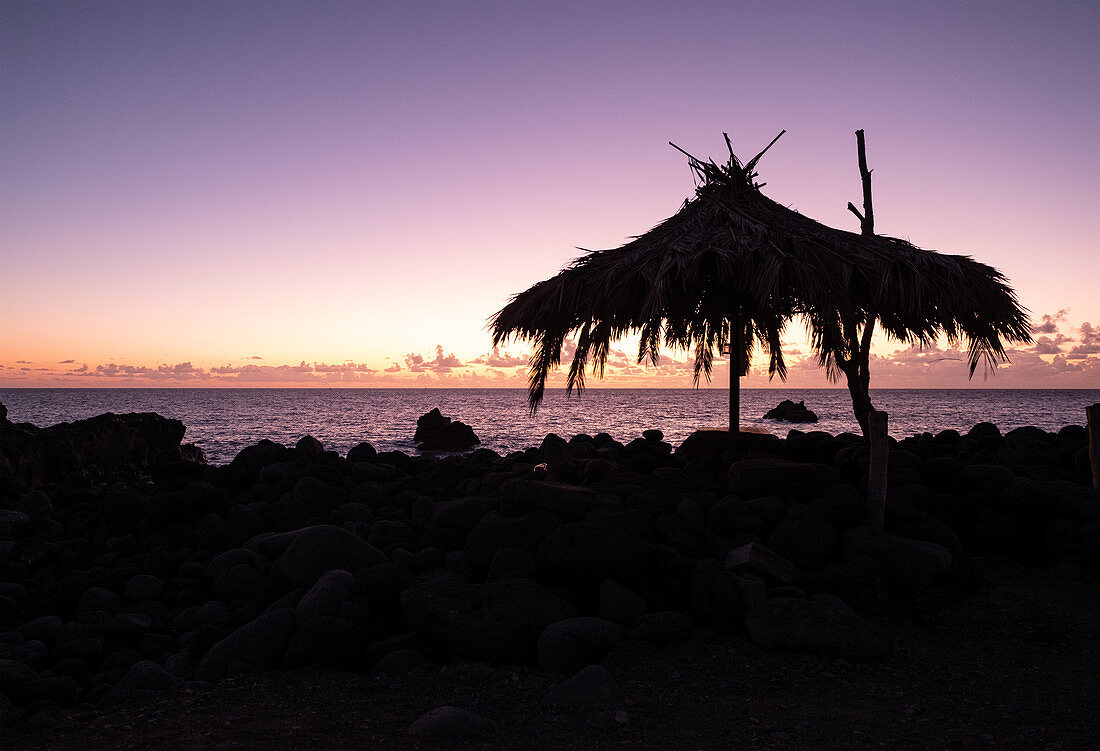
[0,0,1100,388]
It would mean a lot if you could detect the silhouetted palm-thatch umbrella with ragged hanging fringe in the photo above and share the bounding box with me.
[490,133,1031,431]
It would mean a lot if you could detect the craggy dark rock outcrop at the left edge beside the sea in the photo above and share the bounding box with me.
[0,406,205,487]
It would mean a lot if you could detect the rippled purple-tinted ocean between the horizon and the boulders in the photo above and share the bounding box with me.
[0,388,1100,464]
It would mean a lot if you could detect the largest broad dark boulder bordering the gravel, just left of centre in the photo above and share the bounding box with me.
[400,579,574,662]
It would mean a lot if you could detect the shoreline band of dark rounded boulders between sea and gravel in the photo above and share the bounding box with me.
[0,404,1098,739]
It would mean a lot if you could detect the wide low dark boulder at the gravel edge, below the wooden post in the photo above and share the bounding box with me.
[745,597,890,662]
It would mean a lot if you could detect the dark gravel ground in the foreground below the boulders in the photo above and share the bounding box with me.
[0,566,1100,751]
